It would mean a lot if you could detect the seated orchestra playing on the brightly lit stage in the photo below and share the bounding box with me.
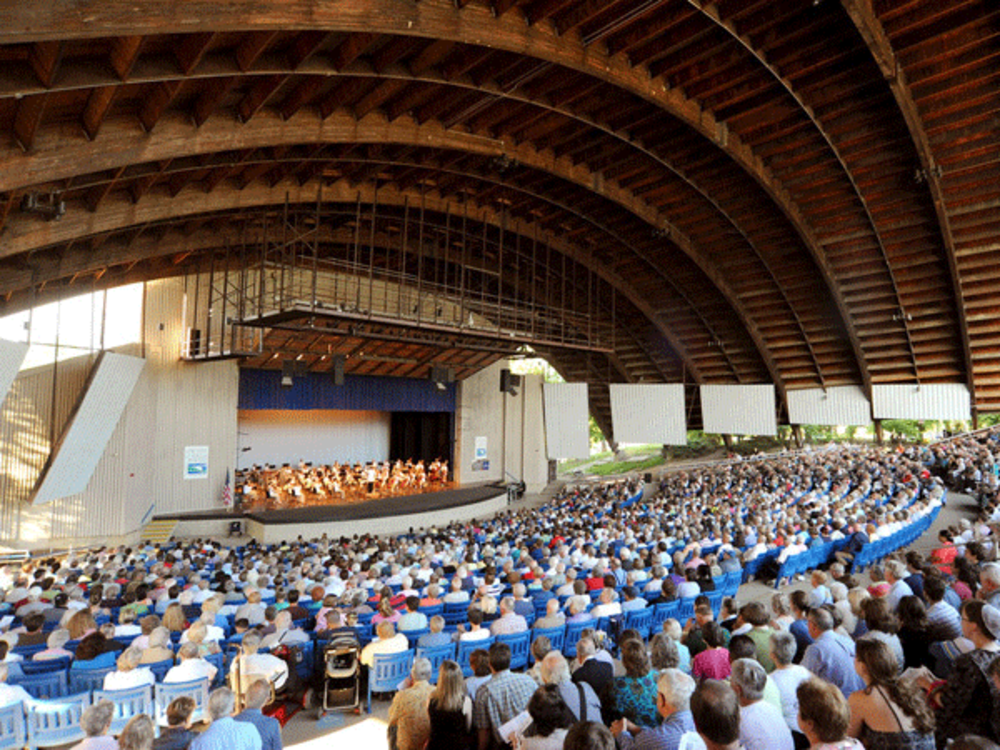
[235,458,451,510]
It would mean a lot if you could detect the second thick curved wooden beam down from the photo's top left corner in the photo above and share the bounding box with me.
[0,111,785,394]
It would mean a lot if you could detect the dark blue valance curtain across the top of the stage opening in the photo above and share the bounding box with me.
[239,369,455,413]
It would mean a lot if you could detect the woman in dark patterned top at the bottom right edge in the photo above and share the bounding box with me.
[937,599,1000,745]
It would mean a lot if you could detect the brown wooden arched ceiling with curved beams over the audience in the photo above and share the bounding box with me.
[0,0,1000,418]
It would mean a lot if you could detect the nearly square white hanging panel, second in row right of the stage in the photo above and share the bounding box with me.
[610,383,687,445]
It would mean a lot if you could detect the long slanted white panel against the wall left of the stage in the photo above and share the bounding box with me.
[31,352,146,505]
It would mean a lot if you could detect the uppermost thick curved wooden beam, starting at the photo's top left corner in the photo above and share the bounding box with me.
[0,0,870,382]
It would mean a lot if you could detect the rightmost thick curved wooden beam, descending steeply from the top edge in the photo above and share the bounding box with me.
[841,0,976,406]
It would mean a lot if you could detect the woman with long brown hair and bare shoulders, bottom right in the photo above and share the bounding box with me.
[847,639,935,750]
